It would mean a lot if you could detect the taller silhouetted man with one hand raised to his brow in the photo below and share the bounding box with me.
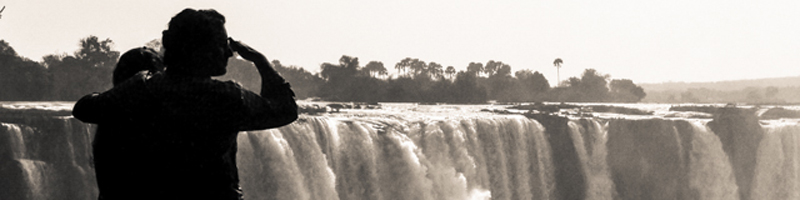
[73,9,297,199]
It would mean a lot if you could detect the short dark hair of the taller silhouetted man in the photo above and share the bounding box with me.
[161,8,225,76]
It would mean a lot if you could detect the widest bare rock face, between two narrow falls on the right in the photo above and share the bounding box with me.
[607,119,694,199]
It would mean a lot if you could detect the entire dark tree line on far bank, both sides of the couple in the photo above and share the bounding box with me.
[0,36,646,103]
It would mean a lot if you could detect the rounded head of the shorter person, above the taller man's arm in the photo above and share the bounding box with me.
[112,47,164,86]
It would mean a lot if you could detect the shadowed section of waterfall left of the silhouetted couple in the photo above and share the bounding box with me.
[0,117,98,199]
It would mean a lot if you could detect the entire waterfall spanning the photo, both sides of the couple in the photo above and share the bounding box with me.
[0,104,800,200]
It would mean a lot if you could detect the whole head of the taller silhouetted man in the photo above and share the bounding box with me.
[161,8,233,76]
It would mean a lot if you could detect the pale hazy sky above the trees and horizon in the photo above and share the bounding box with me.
[0,0,800,84]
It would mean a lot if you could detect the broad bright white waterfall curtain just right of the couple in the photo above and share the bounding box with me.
[237,116,553,200]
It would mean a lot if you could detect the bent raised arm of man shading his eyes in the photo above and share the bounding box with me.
[228,39,298,130]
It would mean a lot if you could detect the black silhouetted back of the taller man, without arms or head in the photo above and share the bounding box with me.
[139,75,266,199]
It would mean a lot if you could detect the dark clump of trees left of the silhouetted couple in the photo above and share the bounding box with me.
[0,36,119,101]
